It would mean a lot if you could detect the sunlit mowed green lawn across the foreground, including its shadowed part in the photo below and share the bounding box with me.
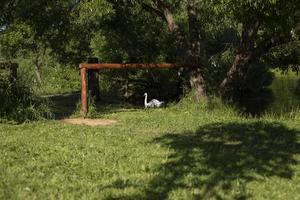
[0,99,300,199]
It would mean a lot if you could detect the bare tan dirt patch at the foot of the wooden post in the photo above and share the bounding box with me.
[61,118,117,126]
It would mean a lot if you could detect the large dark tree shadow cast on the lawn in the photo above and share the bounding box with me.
[139,122,300,199]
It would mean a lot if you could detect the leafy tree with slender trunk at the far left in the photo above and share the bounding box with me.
[0,0,74,83]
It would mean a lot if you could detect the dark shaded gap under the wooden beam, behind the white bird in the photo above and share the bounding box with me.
[100,68,184,105]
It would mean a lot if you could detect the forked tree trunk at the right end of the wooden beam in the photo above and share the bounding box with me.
[143,0,206,100]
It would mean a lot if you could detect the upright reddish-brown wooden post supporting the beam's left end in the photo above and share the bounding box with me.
[80,65,88,117]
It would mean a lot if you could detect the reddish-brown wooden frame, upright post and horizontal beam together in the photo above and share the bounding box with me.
[79,63,193,116]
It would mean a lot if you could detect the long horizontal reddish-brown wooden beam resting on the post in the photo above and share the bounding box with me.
[80,63,193,69]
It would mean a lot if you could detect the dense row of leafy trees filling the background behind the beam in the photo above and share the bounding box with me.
[0,0,300,112]
